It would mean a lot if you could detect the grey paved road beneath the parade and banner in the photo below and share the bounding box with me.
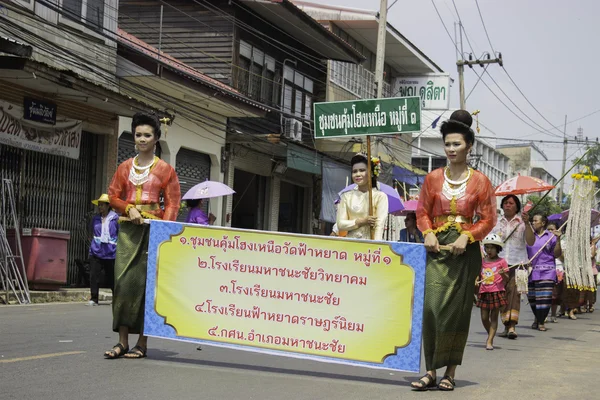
[0,303,600,400]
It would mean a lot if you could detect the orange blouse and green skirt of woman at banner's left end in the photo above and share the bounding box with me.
[108,157,181,333]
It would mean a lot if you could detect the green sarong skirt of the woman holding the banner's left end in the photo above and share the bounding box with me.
[112,222,150,334]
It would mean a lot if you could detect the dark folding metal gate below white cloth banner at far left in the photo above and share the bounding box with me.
[0,132,99,285]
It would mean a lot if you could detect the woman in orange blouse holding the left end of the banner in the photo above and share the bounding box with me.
[104,113,181,358]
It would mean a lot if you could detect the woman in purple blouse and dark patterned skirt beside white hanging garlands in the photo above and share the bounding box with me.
[523,213,562,332]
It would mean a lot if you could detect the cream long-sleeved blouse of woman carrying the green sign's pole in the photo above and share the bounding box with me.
[337,186,388,240]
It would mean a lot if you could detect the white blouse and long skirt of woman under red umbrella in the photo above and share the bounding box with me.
[492,215,529,326]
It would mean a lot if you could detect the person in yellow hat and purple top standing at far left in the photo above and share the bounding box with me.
[88,194,119,306]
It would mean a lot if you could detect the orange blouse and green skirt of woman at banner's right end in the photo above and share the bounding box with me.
[417,168,496,371]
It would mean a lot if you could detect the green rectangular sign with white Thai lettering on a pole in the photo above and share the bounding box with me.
[314,96,421,139]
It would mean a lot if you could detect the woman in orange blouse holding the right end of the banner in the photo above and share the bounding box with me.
[411,110,496,390]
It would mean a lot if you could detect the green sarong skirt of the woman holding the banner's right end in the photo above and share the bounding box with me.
[423,228,481,371]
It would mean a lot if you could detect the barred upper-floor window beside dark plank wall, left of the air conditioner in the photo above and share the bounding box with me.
[237,40,278,105]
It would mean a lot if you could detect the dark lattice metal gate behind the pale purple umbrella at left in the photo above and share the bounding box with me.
[175,148,210,222]
